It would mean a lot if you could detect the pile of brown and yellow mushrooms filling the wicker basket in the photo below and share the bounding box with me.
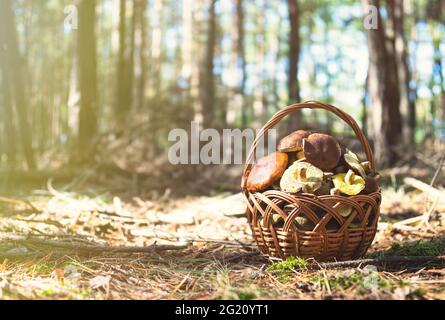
[247,130,380,230]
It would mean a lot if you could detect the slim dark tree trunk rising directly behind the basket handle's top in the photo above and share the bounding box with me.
[287,0,303,130]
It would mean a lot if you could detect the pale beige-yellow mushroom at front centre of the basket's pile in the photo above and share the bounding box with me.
[280,161,323,193]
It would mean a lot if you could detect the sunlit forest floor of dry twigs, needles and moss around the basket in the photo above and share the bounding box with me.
[0,156,445,299]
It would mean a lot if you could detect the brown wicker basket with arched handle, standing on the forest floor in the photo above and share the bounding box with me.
[241,101,381,261]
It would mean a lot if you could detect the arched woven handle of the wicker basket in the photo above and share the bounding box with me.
[241,101,375,191]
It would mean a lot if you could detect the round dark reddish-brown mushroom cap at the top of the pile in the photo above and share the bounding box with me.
[303,133,341,171]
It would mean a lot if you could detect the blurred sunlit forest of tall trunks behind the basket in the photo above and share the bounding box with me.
[0,0,445,190]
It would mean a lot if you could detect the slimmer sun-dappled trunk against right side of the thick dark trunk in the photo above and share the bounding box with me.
[387,0,416,144]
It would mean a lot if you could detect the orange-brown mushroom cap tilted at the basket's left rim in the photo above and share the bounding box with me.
[247,152,288,192]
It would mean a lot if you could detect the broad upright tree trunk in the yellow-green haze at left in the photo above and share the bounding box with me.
[77,0,98,152]
